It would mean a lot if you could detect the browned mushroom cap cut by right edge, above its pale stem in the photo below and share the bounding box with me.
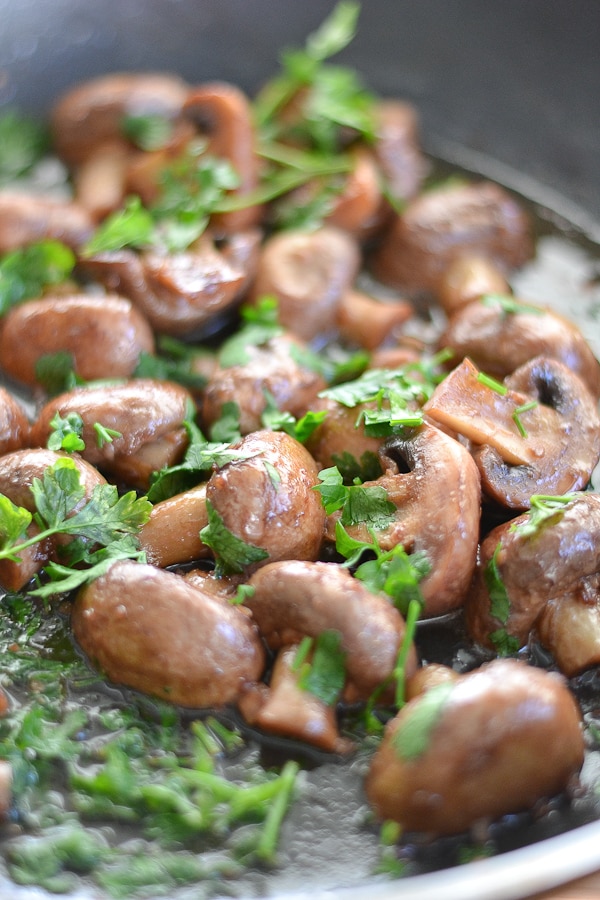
[465,493,600,649]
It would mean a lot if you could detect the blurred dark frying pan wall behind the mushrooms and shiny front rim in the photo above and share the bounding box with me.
[0,0,600,900]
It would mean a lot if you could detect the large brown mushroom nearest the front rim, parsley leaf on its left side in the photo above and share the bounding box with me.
[366,659,584,836]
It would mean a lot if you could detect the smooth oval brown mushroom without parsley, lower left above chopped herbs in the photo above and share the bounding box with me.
[72,560,265,707]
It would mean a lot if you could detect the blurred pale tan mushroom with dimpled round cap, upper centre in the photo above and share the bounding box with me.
[251,226,360,341]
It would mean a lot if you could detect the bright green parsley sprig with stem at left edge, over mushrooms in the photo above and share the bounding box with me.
[0,457,152,597]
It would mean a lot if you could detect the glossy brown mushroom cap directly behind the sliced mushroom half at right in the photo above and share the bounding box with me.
[439,295,600,398]
